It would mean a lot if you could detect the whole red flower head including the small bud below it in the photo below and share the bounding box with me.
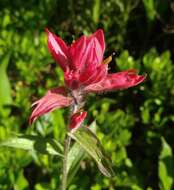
[30,29,145,129]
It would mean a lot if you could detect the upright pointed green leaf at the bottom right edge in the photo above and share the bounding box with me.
[159,138,174,190]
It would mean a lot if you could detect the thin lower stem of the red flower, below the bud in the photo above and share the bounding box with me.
[61,136,71,190]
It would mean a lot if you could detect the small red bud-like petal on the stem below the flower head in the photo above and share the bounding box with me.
[69,111,87,129]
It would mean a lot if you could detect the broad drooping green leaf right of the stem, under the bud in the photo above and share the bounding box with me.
[68,127,114,177]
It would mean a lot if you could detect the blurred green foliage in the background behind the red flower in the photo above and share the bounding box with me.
[0,0,174,190]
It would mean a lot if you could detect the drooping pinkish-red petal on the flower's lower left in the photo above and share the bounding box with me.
[29,87,73,124]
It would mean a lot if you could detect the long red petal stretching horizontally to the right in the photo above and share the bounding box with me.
[85,69,146,92]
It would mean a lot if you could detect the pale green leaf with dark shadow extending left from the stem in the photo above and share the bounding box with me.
[0,135,63,157]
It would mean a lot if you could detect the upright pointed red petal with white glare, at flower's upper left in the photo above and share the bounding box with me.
[46,29,68,71]
